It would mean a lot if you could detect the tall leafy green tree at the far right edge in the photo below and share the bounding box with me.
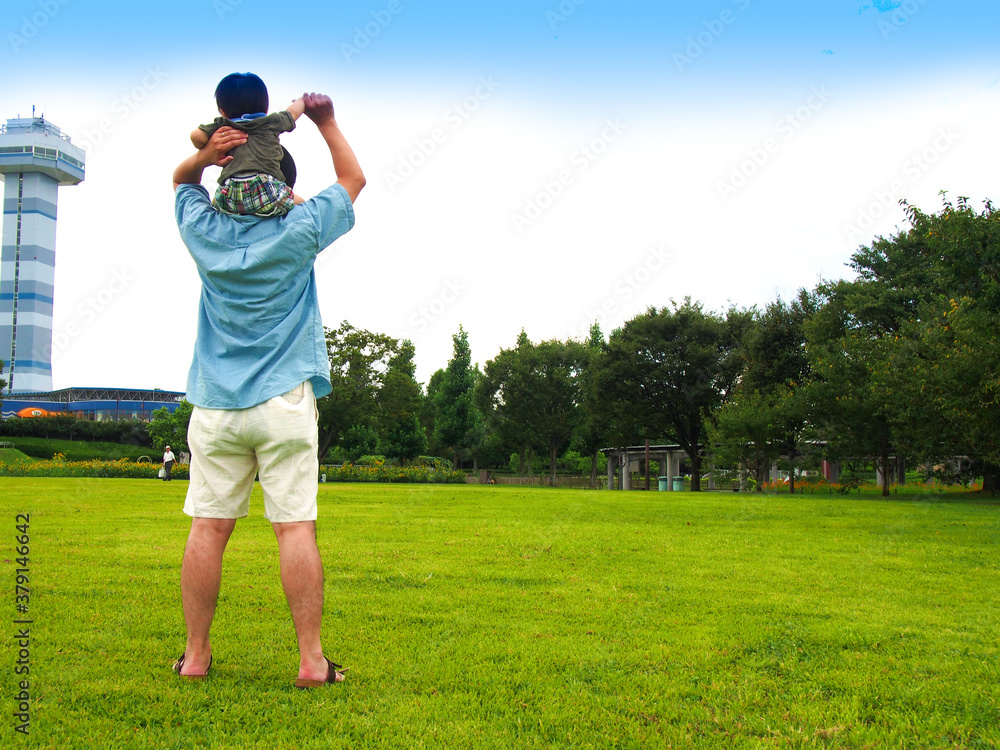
[868,198,1000,492]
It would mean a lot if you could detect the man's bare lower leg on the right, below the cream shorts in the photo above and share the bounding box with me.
[271,521,338,681]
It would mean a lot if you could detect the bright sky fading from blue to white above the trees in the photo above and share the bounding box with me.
[0,0,1000,391]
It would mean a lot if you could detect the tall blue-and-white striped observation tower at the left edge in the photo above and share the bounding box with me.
[0,116,84,393]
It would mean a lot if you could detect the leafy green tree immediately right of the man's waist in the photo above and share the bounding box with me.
[317,320,399,461]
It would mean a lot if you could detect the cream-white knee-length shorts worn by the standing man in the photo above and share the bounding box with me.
[184,381,319,523]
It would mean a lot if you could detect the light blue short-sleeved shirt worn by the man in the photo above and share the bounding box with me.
[175,185,354,409]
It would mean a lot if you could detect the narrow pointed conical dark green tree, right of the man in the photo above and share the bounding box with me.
[434,326,481,469]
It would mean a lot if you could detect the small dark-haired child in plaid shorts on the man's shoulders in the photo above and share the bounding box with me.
[191,73,305,217]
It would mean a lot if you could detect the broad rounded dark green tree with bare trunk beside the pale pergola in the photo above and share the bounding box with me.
[600,299,741,492]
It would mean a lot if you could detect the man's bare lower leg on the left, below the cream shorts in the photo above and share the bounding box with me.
[181,518,236,675]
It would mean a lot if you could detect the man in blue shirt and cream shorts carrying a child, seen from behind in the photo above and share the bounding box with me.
[174,89,365,687]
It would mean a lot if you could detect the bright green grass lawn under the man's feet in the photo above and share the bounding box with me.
[0,478,1000,749]
